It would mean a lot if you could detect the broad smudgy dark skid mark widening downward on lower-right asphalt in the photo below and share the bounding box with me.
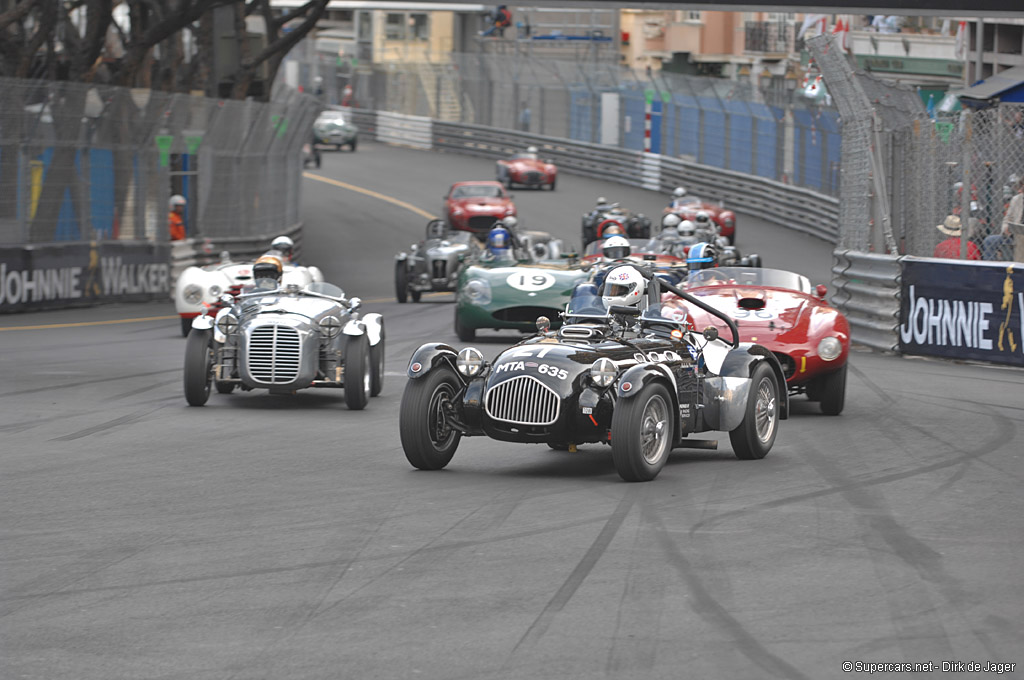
[796,433,969,658]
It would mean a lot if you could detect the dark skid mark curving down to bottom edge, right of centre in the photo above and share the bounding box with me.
[640,506,810,680]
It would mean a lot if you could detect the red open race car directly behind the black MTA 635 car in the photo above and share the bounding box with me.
[666,267,850,416]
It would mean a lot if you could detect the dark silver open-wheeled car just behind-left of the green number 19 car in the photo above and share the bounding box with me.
[394,219,480,302]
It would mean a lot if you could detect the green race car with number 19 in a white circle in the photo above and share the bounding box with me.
[455,253,589,342]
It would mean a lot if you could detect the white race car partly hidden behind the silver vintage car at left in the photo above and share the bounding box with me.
[174,257,324,336]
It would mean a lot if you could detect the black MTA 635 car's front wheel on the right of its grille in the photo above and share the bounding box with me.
[611,383,675,481]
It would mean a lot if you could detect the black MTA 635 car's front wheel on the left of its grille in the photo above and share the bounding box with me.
[398,368,462,470]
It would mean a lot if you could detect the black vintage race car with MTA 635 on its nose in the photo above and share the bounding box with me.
[399,265,788,481]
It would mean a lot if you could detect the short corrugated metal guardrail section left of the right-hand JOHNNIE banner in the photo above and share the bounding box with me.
[831,249,902,352]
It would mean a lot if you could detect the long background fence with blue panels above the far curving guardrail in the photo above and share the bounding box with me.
[302,50,841,196]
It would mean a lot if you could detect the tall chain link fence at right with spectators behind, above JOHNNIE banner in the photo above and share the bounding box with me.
[807,36,1024,260]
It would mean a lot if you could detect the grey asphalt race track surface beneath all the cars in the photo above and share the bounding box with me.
[0,143,1024,680]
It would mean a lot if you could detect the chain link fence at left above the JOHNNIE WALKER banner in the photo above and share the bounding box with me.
[0,79,323,244]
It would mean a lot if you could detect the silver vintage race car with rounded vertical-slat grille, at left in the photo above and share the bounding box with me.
[184,283,384,411]
